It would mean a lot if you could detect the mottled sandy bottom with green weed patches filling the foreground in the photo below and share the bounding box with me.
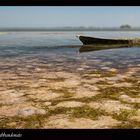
[0,56,140,129]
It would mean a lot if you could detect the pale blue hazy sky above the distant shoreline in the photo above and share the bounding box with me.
[0,6,140,28]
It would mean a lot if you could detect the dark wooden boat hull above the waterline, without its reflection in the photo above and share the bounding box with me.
[78,36,140,45]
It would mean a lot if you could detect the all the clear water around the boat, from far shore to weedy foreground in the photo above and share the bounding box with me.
[0,32,140,129]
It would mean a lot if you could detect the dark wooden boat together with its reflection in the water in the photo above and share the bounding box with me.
[77,36,140,52]
